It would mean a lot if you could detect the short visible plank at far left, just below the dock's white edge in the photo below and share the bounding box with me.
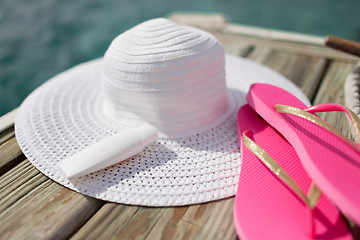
[0,137,25,175]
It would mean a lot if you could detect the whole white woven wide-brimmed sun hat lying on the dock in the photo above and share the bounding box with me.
[15,19,308,206]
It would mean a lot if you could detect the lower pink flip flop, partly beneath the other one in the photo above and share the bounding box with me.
[234,105,351,240]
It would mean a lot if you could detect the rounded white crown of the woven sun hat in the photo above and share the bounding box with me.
[102,18,229,136]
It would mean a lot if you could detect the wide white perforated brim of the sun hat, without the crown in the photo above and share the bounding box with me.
[15,55,309,206]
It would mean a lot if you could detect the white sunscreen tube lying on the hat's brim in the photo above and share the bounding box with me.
[58,124,158,178]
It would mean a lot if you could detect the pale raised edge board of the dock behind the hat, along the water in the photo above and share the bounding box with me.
[169,13,358,63]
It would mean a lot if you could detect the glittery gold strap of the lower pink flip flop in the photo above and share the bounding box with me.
[243,132,321,209]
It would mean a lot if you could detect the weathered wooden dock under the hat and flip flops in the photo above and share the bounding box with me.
[0,14,359,240]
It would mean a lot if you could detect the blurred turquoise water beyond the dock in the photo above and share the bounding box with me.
[0,0,360,115]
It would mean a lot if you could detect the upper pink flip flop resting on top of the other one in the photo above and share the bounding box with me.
[247,84,360,224]
